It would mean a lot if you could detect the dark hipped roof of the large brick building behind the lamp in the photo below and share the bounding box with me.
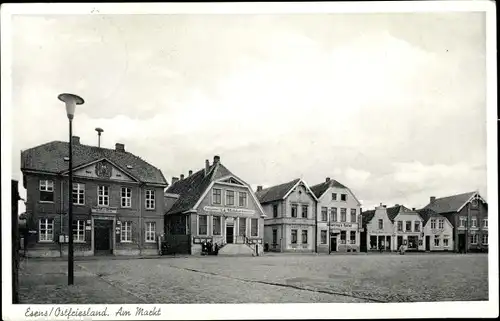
[21,141,167,186]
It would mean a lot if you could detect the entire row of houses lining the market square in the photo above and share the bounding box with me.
[21,136,488,256]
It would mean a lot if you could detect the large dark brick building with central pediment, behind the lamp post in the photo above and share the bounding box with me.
[21,136,168,256]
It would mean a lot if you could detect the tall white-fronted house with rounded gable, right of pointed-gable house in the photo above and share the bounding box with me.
[311,177,361,252]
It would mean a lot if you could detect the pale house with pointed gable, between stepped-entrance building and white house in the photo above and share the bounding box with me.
[256,178,318,252]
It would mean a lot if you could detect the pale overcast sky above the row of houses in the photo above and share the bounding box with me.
[12,13,487,209]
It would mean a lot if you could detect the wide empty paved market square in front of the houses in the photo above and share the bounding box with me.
[20,254,488,304]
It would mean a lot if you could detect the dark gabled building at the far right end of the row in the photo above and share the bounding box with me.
[424,192,488,252]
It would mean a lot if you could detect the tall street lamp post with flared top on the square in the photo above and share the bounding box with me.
[57,94,84,285]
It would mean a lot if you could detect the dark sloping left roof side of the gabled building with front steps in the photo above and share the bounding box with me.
[165,162,234,214]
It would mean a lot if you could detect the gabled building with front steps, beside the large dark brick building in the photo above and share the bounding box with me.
[164,156,265,255]
